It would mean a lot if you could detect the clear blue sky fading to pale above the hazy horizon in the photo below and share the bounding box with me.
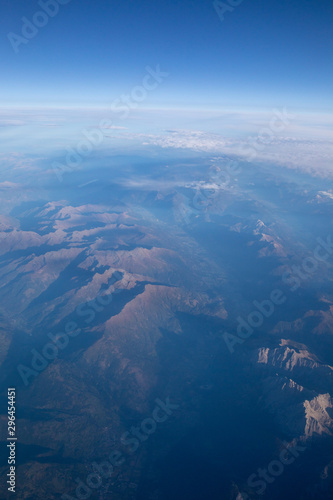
[0,0,333,113]
